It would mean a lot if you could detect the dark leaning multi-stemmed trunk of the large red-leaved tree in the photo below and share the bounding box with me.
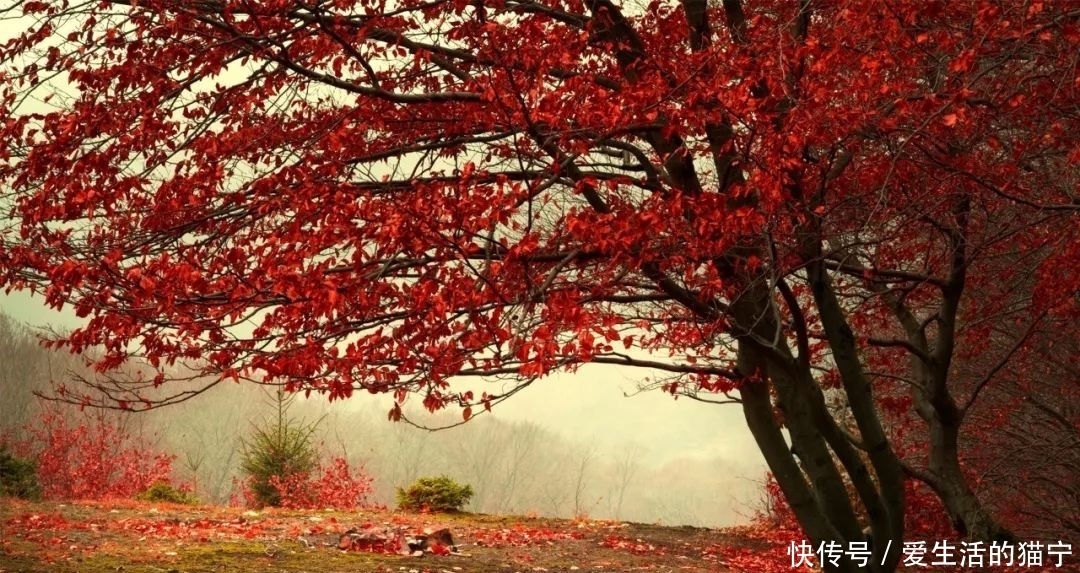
[732,276,903,573]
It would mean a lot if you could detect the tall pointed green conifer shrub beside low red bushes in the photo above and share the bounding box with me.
[241,392,319,507]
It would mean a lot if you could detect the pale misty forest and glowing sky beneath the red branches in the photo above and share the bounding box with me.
[0,304,765,527]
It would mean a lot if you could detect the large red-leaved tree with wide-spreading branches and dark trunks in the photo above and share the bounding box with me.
[0,0,1080,571]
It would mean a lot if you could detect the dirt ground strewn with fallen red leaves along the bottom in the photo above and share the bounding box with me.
[0,499,768,573]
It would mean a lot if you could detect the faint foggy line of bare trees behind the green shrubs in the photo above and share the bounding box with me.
[0,314,764,527]
